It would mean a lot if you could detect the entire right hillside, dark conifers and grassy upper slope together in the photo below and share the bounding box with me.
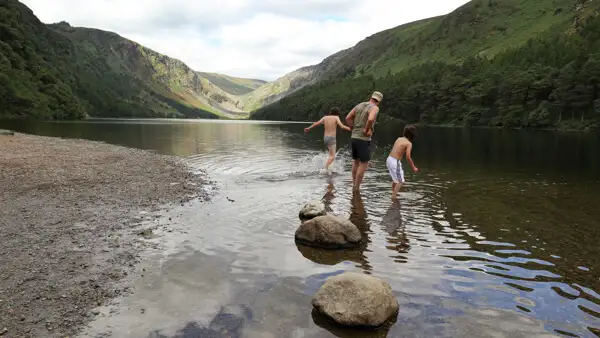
[251,0,600,128]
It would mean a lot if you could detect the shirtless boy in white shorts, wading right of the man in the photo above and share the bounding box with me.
[386,125,419,201]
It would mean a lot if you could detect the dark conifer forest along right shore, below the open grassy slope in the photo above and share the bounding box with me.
[252,3,600,129]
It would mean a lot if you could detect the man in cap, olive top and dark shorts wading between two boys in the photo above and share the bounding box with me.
[346,92,383,190]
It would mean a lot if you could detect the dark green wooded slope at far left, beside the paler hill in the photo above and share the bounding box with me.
[0,0,217,119]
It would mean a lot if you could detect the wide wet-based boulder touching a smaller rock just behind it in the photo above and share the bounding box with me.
[294,215,362,249]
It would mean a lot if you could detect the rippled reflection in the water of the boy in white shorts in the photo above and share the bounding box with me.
[381,201,410,263]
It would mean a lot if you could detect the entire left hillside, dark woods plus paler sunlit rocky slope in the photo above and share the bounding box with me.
[0,0,264,119]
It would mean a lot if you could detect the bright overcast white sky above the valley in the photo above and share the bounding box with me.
[21,0,468,80]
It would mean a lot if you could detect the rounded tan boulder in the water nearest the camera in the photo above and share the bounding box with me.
[312,272,399,329]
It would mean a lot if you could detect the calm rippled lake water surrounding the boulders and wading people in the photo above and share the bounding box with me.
[3,120,600,338]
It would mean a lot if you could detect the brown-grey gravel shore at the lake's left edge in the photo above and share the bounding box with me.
[0,134,208,337]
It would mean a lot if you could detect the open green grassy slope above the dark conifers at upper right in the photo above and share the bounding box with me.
[365,0,575,76]
